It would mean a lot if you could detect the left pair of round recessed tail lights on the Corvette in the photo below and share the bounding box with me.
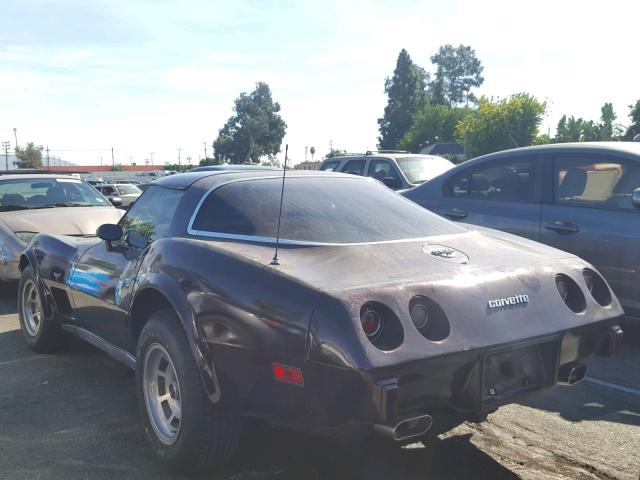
[360,295,451,351]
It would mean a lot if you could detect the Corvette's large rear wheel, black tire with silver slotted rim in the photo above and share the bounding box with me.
[136,310,241,473]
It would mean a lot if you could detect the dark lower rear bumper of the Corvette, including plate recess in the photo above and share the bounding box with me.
[305,319,622,439]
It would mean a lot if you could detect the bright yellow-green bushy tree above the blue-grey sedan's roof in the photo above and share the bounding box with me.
[456,93,546,156]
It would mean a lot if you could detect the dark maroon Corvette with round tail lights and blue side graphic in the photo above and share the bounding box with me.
[18,171,622,472]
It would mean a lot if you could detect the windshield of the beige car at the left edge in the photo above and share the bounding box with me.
[0,178,109,212]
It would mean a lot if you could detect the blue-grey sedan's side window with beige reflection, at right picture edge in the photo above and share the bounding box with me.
[555,154,640,211]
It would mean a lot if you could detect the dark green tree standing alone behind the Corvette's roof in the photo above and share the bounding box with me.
[213,82,287,164]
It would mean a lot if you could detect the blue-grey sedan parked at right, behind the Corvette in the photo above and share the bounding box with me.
[404,142,640,318]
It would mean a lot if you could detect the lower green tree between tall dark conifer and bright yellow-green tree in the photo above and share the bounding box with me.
[398,103,471,153]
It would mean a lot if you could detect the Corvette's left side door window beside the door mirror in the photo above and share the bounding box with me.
[120,186,184,243]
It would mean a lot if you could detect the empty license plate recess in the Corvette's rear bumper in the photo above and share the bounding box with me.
[481,339,560,410]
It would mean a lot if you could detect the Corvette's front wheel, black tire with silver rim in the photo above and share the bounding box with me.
[18,265,64,353]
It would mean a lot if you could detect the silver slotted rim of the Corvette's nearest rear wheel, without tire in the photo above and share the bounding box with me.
[142,343,182,445]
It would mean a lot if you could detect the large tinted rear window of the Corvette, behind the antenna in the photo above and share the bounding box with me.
[192,177,467,244]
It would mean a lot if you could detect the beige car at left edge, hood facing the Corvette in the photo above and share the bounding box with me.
[0,174,122,282]
